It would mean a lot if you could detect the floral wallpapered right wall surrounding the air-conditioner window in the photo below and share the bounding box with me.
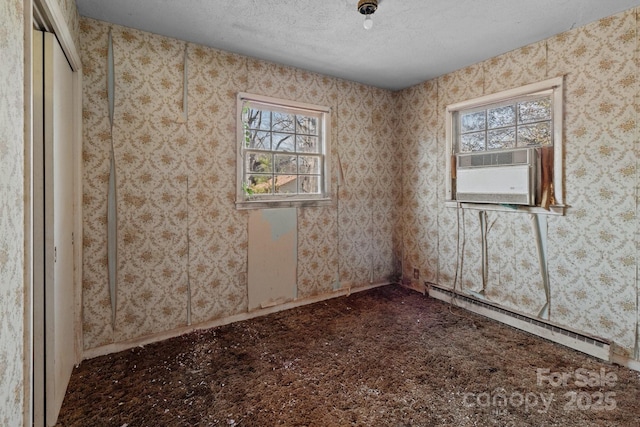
[399,9,640,355]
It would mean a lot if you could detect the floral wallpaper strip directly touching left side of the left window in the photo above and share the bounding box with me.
[186,43,248,323]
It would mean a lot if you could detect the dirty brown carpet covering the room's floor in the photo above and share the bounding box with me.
[58,285,640,427]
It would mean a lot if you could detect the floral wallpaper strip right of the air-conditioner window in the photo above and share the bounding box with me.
[548,10,640,351]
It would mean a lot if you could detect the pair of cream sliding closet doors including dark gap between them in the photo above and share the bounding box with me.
[33,31,75,426]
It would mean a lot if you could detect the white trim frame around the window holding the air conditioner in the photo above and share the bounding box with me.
[445,76,566,215]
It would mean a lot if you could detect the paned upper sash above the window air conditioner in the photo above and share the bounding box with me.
[454,91,553,153]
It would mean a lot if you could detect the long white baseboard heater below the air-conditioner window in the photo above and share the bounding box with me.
[429,285,613,362]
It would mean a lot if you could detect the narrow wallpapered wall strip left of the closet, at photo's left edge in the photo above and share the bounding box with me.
[0,0,25,426]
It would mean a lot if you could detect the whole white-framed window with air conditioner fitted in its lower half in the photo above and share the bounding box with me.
[446,77,564,213]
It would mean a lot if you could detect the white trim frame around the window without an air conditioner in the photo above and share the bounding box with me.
[236,92,333,209]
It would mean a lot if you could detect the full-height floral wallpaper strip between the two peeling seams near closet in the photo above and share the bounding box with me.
[112,27,190,341]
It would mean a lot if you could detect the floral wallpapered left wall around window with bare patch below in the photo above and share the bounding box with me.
[80,18,400,349]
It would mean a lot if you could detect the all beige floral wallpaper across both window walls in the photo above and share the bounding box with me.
[80,9,640,362]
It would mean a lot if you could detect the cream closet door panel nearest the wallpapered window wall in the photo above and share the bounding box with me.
[44,29,75,425]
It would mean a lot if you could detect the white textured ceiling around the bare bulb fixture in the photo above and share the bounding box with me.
[76,0,640,90]
